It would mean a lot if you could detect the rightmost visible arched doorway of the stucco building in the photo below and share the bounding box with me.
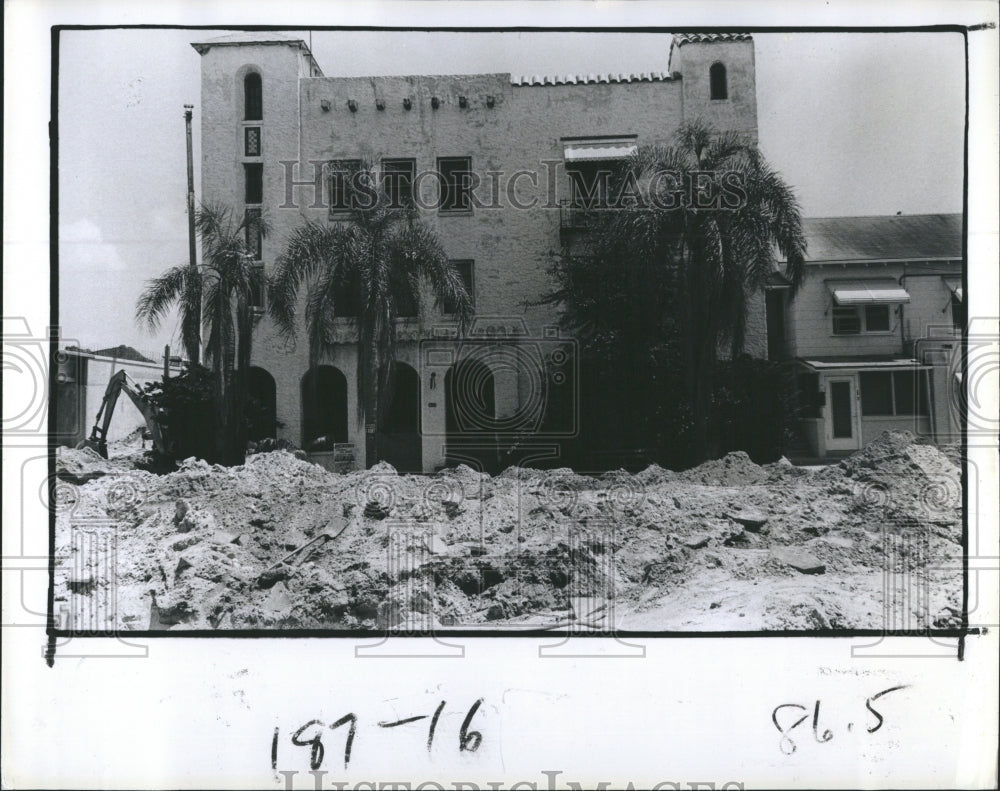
[444,358,500,473]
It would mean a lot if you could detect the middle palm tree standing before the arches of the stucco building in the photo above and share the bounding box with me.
[268,160,472,466]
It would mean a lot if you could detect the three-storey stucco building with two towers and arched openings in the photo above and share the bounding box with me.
[193,34,767,471]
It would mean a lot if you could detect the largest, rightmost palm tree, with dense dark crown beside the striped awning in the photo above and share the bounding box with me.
[548,122,806,461]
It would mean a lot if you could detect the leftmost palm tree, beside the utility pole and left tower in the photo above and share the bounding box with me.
[136,204,268,464]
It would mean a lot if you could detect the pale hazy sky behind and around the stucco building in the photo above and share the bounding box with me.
[58,29,965,357]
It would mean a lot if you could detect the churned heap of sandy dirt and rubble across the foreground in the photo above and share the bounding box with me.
[55,432,962,630]
